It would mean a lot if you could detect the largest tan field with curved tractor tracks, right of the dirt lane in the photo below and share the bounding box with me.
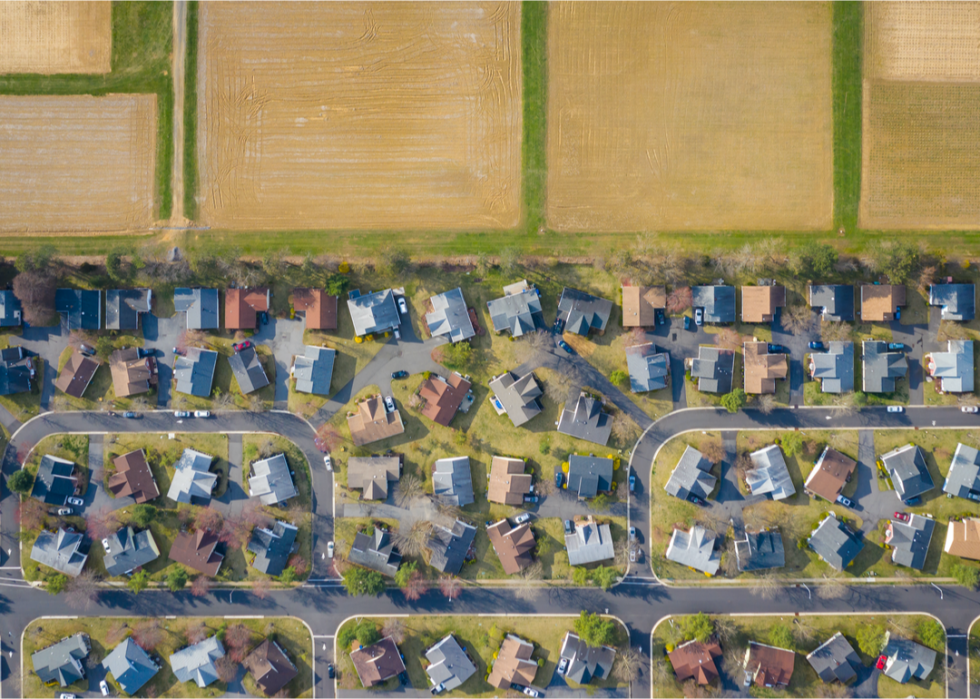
[198,2,521,229]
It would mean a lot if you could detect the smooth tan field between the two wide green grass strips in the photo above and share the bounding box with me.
[548,2,833,231]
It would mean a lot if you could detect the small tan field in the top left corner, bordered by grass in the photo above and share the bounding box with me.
[0,2,112,74]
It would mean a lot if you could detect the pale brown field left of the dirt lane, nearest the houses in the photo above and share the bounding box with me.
[0,95,157,233]
